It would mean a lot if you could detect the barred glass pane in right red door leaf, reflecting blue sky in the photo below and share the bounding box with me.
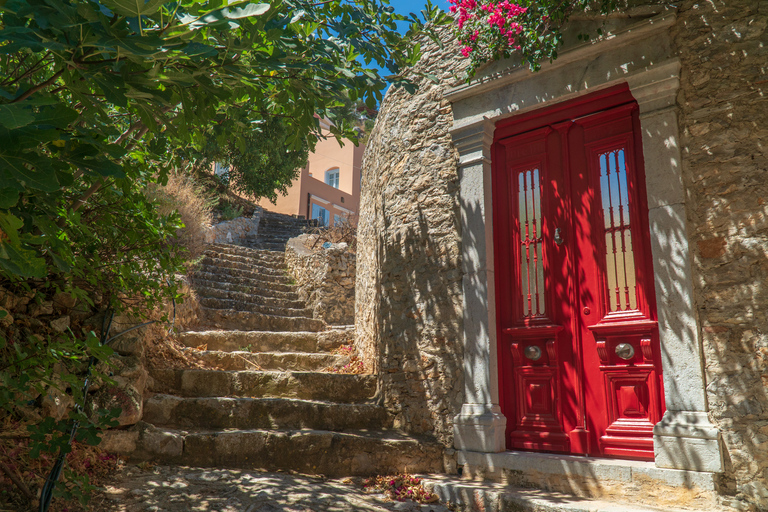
[599,149,637,312]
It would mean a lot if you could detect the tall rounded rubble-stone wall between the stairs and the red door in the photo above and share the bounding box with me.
[355,31,464,446]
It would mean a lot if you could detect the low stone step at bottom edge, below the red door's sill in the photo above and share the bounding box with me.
[424,475,725,512]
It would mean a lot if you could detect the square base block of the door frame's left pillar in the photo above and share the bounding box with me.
[453,404,507,453]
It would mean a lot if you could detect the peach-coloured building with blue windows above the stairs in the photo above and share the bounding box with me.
[258,120,365,226]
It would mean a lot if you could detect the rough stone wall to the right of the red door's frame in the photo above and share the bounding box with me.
[673,0,768,510]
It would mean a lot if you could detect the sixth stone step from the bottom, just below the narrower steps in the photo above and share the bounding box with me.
[199,307,325,332]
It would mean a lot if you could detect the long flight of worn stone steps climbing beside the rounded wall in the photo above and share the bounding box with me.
[113,242,443,476]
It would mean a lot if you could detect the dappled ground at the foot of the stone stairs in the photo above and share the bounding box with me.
[90,465,449,512]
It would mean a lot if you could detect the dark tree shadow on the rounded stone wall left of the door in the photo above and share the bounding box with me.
[378,205,463,446]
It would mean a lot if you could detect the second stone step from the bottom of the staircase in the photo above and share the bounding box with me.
[143,394,392,431]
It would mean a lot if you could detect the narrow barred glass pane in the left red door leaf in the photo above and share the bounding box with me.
[517,169,546,317]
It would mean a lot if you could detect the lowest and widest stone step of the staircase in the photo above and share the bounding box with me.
[108,422,443,477]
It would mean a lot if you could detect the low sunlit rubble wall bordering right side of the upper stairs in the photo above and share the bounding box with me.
[285,234,356,326]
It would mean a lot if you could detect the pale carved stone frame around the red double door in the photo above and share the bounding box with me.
[446,12,723,472]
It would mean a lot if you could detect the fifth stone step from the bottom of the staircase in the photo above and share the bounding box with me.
[178,329,355,352]
